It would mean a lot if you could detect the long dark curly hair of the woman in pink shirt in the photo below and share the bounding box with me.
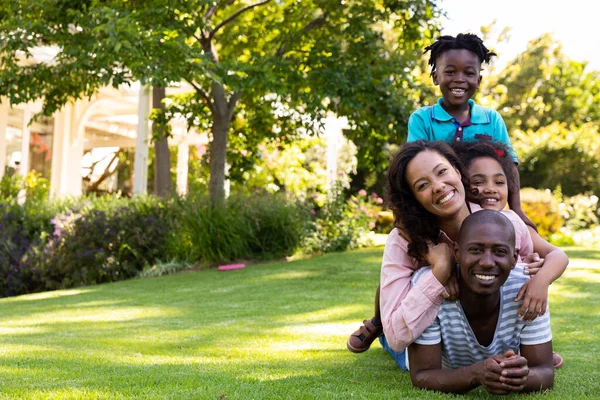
[385,140,469,260]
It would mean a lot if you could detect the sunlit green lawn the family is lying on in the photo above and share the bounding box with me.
[0,248,600,399]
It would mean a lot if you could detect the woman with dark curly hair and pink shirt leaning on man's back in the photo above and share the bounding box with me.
[348,141,532,369]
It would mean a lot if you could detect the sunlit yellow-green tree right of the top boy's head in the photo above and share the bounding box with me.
[488,34,600,131]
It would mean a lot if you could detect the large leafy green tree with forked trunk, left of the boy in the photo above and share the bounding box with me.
[0,0,438,203]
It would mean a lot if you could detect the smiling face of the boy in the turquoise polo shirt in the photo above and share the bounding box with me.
[432,49,481,107]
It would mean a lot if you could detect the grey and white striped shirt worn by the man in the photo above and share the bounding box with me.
[413,265,552,369]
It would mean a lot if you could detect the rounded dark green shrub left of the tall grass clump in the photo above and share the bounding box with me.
[34,197,171,289]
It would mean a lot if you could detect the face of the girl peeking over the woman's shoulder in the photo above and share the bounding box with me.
[469,157,508,211]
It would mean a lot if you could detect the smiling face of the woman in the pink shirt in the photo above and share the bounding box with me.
[405,150,466,218]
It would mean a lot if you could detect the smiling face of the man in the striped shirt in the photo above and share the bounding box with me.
[455,222,517,296]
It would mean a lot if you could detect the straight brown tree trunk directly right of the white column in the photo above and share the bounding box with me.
[152,87,171,197]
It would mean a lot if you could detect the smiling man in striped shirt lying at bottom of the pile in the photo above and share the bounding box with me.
[408,210,554,395]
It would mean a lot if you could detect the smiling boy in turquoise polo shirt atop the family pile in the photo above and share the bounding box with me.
[407,33,536,229]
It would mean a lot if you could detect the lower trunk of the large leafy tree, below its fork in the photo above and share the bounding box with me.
[208,113,230,206]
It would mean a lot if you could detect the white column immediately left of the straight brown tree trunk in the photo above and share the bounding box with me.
[133,86,150,194]
